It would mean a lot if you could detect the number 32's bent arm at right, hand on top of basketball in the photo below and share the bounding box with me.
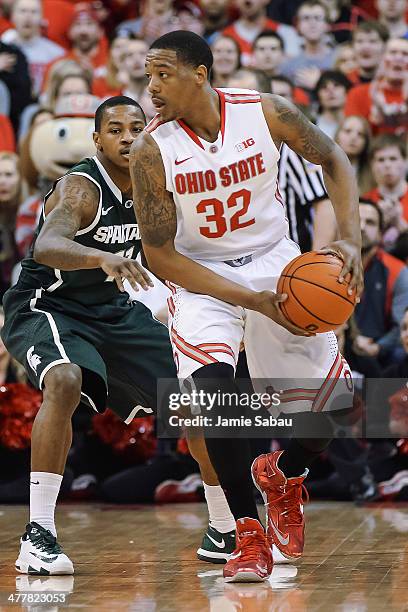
[262,94,363,293]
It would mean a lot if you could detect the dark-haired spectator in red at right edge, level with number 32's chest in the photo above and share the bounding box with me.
[364,134,408,244]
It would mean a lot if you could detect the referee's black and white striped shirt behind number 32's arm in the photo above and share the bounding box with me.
[278,143,328,253]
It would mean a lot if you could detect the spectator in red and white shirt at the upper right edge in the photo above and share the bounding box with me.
[344,38,408,135]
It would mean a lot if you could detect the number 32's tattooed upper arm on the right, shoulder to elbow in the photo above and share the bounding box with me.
[268,96,335,164]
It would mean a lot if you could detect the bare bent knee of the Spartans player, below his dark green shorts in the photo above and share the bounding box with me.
[44,363,82,411]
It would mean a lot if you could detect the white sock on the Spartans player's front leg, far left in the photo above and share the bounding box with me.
[30,472,62,537]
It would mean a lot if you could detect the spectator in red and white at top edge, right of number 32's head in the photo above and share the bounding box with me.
[223,0,300,66]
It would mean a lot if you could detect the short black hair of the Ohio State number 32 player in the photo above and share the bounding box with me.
[150,30,213,75]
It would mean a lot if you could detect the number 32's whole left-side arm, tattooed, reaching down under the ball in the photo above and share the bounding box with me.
[130,132,311,336]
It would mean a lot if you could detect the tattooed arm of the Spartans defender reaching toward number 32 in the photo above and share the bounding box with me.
[33,175,153,291]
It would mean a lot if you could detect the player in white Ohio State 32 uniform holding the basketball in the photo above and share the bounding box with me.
[130,32,362,581]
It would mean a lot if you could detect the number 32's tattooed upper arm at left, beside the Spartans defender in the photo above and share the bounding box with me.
[130,133,177,247]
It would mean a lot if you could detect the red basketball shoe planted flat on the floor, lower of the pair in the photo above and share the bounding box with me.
[224,518,273,582]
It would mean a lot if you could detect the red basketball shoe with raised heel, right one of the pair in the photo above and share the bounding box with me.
[252,451,308,561]
